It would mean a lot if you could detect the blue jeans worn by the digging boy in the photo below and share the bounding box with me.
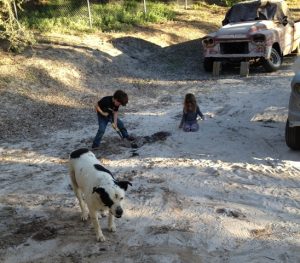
[92,113,128,148]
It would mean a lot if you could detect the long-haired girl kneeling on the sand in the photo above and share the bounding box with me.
[179,93,204,132]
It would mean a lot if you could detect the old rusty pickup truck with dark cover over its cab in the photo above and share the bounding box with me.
[202,0,300,72]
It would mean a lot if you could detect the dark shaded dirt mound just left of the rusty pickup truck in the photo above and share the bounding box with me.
[112,37,207,80]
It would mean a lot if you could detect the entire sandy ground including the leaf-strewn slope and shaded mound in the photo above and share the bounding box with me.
[0,9,300,263]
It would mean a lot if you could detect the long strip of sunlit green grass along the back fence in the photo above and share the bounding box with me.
[21,0,175,33]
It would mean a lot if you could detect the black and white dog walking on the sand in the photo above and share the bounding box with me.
[69,149,132,241]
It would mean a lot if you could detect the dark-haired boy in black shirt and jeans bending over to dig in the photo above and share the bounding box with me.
[92,90,134,149]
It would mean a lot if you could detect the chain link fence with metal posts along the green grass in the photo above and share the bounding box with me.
[12,0,199,32]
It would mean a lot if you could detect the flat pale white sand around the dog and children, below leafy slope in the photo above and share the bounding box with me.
[0,42,300,263]
